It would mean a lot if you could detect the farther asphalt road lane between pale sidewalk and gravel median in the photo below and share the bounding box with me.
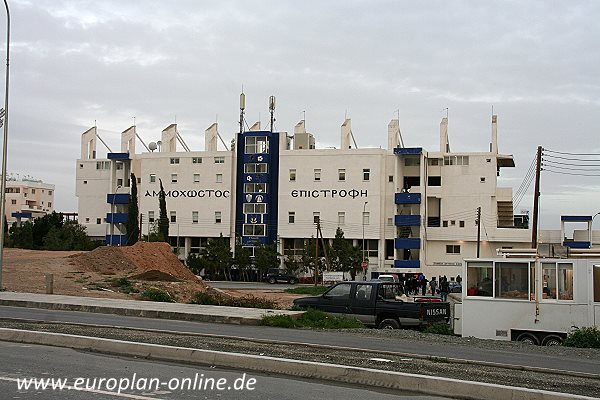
[0,306,600,374]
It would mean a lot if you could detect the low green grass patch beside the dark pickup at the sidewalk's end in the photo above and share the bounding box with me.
[261,308,365,329]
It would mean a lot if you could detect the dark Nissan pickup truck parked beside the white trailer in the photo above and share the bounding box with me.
[294,281,450,329]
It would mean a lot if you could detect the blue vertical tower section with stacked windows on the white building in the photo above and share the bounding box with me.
[235,131,279,246]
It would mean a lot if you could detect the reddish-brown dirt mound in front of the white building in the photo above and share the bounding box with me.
[71,242,201,282]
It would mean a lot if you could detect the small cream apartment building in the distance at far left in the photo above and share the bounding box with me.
[6,176,54,226]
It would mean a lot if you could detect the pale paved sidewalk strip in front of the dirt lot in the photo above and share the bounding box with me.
[0,292,302,325]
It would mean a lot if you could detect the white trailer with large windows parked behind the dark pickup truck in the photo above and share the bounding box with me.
[454,258,600,346]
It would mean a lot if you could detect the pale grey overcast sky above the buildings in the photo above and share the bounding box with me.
[0,0,600,229]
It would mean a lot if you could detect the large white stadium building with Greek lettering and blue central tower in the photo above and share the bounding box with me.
[76,109,531,277]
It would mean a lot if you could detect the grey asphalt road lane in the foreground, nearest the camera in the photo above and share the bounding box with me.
[0,342,447,400]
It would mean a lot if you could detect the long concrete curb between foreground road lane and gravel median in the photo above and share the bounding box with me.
[0,328,593,400]
